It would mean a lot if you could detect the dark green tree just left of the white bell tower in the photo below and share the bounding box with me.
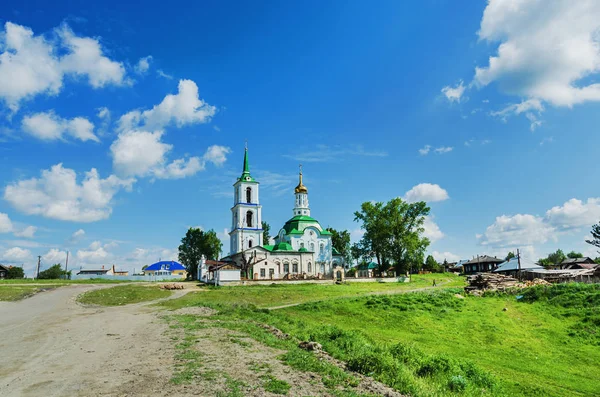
[179,227,223,280]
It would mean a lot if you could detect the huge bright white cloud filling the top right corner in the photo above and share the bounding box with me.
[475,0,600,106]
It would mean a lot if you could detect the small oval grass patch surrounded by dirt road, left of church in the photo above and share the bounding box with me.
[77,285,171,306]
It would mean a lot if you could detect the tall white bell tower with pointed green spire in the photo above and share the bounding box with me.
[229,146,268,255]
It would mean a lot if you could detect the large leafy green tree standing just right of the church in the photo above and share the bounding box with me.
[354,198,430,273]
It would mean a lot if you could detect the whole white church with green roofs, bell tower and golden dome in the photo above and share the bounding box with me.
[221,148,344,280]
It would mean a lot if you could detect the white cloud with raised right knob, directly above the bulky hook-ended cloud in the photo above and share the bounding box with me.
[119,80,216,131]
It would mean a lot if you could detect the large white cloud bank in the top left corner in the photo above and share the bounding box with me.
[0,22,125,112]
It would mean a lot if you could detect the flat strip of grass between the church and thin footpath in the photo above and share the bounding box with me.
[161,274,464,309]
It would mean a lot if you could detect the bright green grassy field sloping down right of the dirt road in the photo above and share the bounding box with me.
[163,275,600,396]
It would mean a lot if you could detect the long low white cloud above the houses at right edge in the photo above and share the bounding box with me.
[476,198,600,248]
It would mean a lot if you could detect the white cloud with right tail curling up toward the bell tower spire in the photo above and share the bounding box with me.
[110,131,231,179]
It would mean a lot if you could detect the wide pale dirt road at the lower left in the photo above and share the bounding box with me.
[0,285,186,396]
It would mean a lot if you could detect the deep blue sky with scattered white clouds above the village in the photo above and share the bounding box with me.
[0,0,600,275]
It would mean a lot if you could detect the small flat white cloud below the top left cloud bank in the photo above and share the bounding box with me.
[22,111,100,142]
